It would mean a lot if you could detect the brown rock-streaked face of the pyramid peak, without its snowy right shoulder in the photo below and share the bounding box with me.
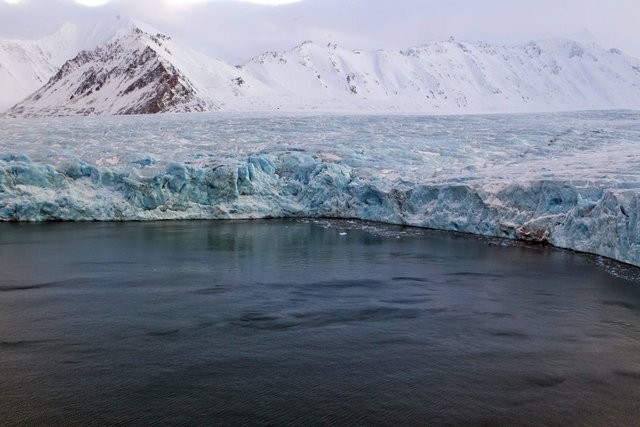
[10,28,212,116]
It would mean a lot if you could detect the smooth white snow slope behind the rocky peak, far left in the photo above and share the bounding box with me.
[0,20,133,111]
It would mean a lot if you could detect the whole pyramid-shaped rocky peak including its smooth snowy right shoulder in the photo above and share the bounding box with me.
[7,23,274,116]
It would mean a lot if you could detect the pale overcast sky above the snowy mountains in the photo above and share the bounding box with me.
[0,0,640,62]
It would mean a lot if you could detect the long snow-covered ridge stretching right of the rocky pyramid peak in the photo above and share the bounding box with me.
[245,39,640,113]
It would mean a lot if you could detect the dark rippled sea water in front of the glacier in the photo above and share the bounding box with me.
[0,220,640,425]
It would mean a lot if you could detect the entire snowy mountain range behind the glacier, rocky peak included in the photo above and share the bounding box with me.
[0,21,640,117]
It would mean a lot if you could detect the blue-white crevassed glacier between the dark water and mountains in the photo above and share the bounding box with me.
[0,111,640,265]
